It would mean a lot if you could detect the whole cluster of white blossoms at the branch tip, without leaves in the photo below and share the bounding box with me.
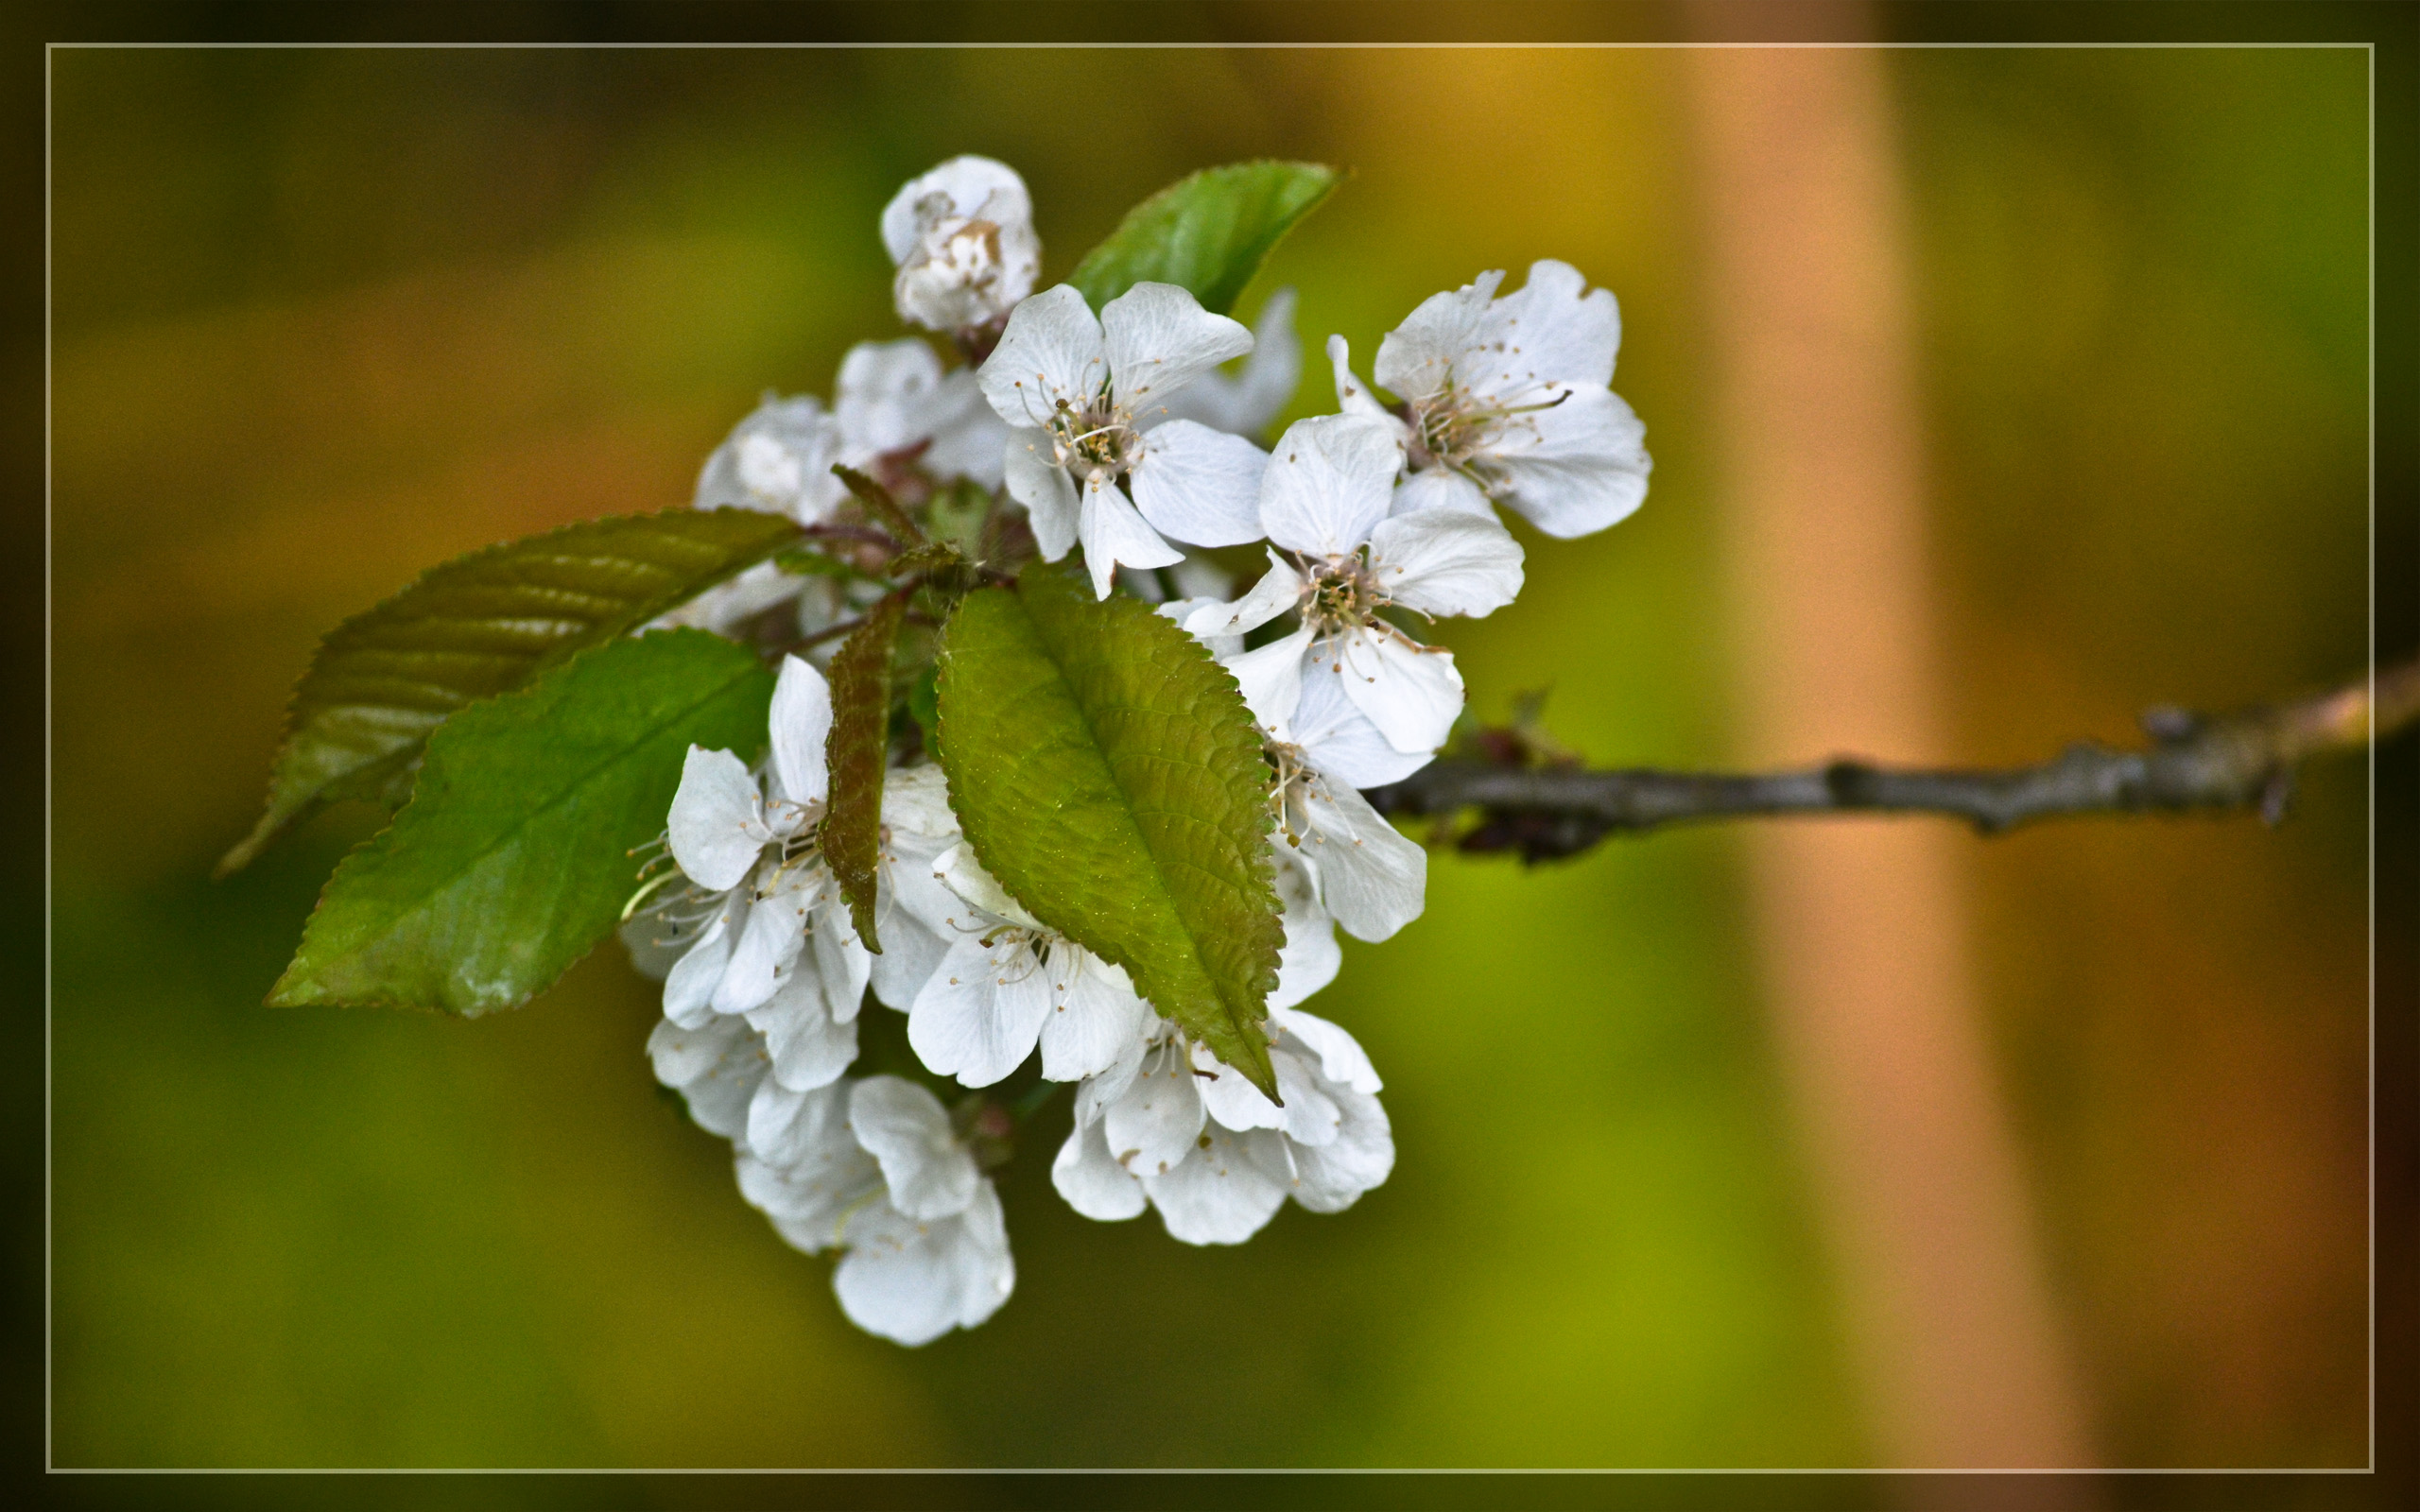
[624,157,1648,1343]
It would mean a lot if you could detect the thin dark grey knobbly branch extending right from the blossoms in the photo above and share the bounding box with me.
[1367,658,2420,861]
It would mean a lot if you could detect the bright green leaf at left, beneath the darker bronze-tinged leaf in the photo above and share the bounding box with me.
[268,629,772,1014]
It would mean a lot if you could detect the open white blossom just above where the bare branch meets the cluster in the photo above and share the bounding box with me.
[1184,414,1522,757]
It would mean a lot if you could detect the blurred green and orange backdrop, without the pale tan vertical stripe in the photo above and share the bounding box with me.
[51,35,2401,1466]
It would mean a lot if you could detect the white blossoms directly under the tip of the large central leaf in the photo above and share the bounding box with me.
[1050,1009,1394,1244]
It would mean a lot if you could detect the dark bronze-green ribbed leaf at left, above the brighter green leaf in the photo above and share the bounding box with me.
[217,510,799,876]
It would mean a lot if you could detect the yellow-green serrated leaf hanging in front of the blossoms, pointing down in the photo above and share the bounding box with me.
[939,561,1285,1098]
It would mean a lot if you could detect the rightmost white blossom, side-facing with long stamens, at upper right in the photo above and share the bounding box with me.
[1328,261,1652,540]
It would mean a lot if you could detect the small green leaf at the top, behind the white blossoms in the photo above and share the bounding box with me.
[1067,163,1343,315]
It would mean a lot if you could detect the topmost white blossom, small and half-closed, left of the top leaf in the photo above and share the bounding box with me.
[881,157,1043,334]
